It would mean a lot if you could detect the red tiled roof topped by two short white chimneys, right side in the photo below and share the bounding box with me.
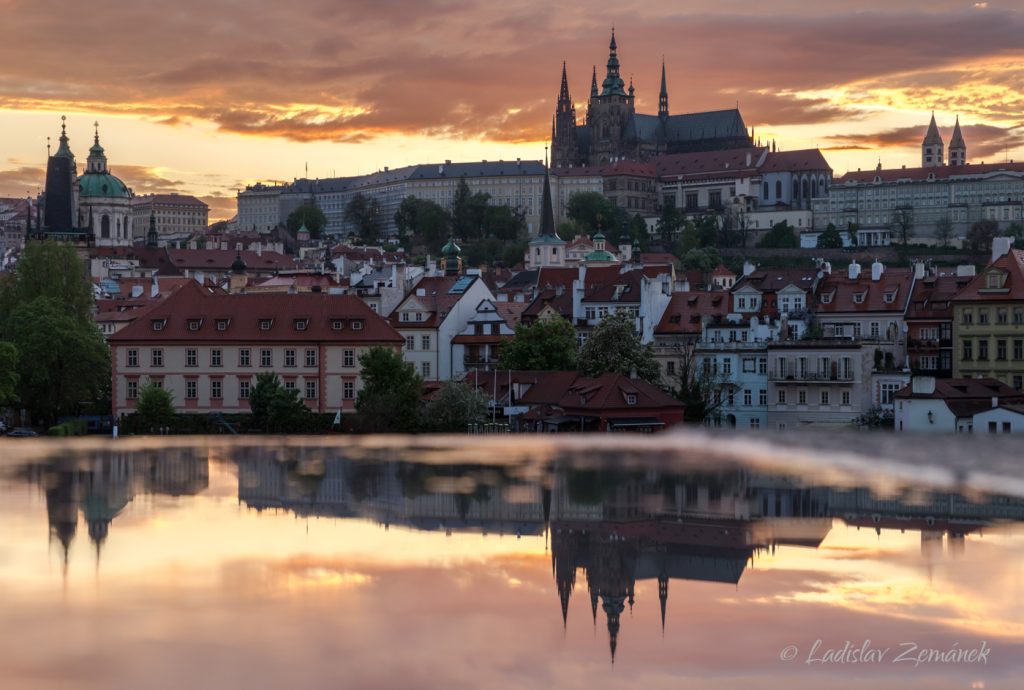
[815,268,913,314]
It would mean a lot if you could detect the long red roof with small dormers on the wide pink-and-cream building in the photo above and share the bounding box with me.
[111,282,403,345]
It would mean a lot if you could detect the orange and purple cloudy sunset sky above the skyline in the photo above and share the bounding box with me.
[0,0,1024,218]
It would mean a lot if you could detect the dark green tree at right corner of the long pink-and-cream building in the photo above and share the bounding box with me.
[355,347,423,433]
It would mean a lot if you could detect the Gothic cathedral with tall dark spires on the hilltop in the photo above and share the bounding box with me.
[551,31,754,168]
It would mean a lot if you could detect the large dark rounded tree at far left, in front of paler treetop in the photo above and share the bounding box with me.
[4,297,111,424]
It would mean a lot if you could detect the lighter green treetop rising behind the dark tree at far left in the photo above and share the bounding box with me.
[0,241,93,329]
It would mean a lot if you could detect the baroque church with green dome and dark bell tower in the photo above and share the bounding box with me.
[34,118,133,247]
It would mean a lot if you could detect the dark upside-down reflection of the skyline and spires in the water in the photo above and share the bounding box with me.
[15,440,1024,662]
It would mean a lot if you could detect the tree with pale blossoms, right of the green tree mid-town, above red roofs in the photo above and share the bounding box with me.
[579,311,662,385]
